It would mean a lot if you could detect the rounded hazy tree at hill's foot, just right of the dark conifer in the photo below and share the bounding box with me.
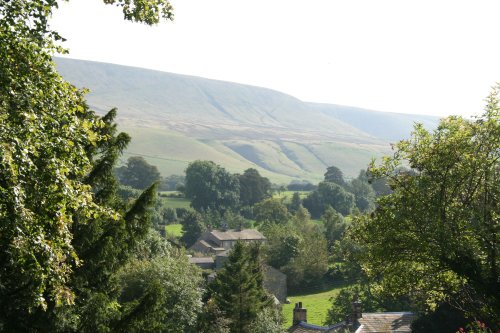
[116,156,161,190]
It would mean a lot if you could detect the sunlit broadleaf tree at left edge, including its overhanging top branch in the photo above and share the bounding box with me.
[0,0,176,331]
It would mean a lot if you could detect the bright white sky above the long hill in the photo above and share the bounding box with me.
[51,0,500,117]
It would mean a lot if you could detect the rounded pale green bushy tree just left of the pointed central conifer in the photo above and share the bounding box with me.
[114,253,202,332]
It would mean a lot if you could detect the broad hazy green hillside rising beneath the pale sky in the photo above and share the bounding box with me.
[55,58,437,183]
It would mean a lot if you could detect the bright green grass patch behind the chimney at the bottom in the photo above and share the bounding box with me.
[283,286,342,328]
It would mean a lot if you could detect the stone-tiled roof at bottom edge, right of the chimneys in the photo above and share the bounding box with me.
[356,312,415,333]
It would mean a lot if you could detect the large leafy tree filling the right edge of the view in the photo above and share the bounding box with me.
[349,87,500,322]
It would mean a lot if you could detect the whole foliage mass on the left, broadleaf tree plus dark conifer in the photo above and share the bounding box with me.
[0,0,181,326]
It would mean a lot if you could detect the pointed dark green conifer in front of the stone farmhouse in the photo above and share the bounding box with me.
[210,242,271,333]
